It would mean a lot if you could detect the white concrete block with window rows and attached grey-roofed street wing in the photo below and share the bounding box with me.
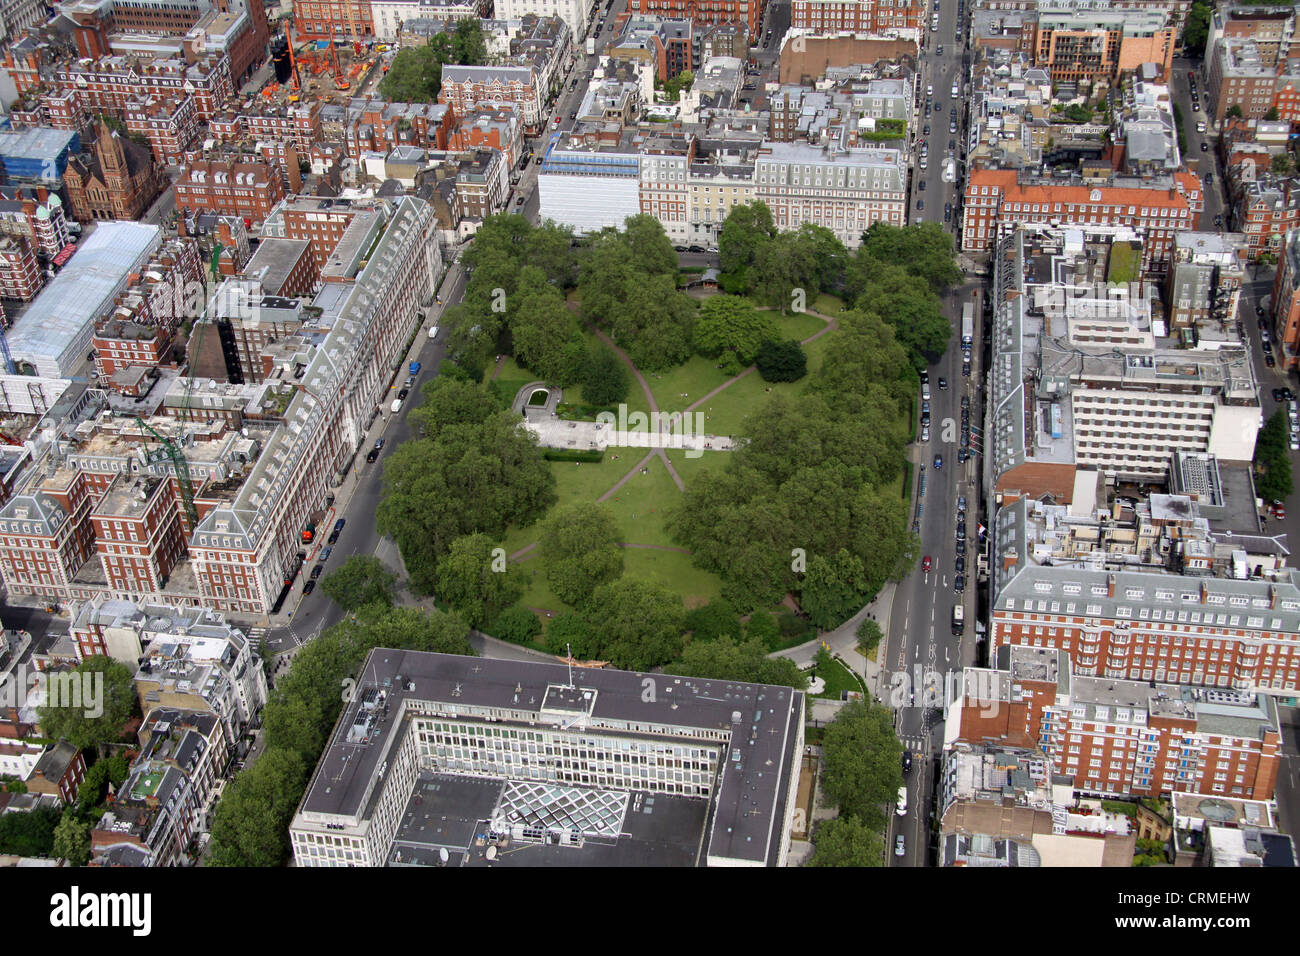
[983,226,1260,512]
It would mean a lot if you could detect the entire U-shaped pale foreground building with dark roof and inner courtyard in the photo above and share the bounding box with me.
[290,649,805,866]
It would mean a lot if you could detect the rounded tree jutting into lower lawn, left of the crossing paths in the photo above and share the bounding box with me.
[538,503,623,607]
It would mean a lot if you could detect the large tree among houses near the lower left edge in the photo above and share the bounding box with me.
[38,656,140,750]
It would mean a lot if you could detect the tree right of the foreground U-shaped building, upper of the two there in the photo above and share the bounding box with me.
[822,698,902,830]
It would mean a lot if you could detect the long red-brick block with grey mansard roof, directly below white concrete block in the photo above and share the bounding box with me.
[989,489,1300,697]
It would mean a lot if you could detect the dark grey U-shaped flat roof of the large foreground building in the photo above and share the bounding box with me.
[299,648,803,864]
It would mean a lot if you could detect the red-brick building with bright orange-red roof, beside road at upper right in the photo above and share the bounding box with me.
[962,169,1205,272]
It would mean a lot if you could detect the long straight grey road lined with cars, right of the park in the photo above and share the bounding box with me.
[884,3,980,866]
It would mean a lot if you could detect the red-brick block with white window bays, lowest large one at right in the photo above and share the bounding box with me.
[946,646,1282,800]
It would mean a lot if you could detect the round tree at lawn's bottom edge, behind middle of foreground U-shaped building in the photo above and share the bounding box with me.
[588,578,686,671]
